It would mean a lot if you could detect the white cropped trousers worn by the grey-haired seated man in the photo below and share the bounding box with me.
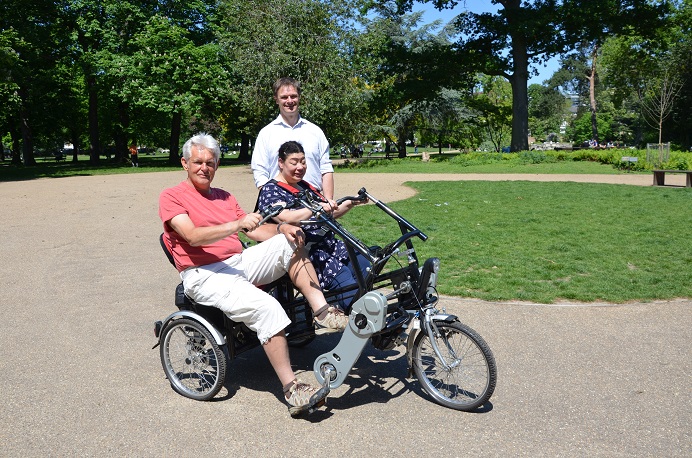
[180,235,295,344]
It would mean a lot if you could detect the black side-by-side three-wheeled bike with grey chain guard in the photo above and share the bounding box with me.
[154,188,497,411]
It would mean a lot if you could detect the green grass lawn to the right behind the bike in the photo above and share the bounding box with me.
[344,182,692,303]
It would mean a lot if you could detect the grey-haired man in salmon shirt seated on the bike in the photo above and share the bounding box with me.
[159,133,348,415]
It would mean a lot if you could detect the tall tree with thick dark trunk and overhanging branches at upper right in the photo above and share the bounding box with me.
[390,0,667,151]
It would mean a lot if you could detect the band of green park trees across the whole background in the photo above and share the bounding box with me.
[0,0,692,165]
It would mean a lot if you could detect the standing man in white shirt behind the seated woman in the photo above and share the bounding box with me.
[251,78,334,201]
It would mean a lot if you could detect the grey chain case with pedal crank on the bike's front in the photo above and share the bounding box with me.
[313,291,387,390]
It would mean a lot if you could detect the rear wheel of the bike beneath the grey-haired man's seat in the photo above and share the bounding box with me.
[161,318,227,401]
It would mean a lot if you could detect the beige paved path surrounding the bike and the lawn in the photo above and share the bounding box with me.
[0,168,692,457]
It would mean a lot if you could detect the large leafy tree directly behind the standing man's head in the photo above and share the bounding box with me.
[218,0,358,160]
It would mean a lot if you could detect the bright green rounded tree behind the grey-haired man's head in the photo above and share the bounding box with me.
[122,1,230,165]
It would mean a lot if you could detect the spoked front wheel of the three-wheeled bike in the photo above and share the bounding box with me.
[412,321,497,411]
